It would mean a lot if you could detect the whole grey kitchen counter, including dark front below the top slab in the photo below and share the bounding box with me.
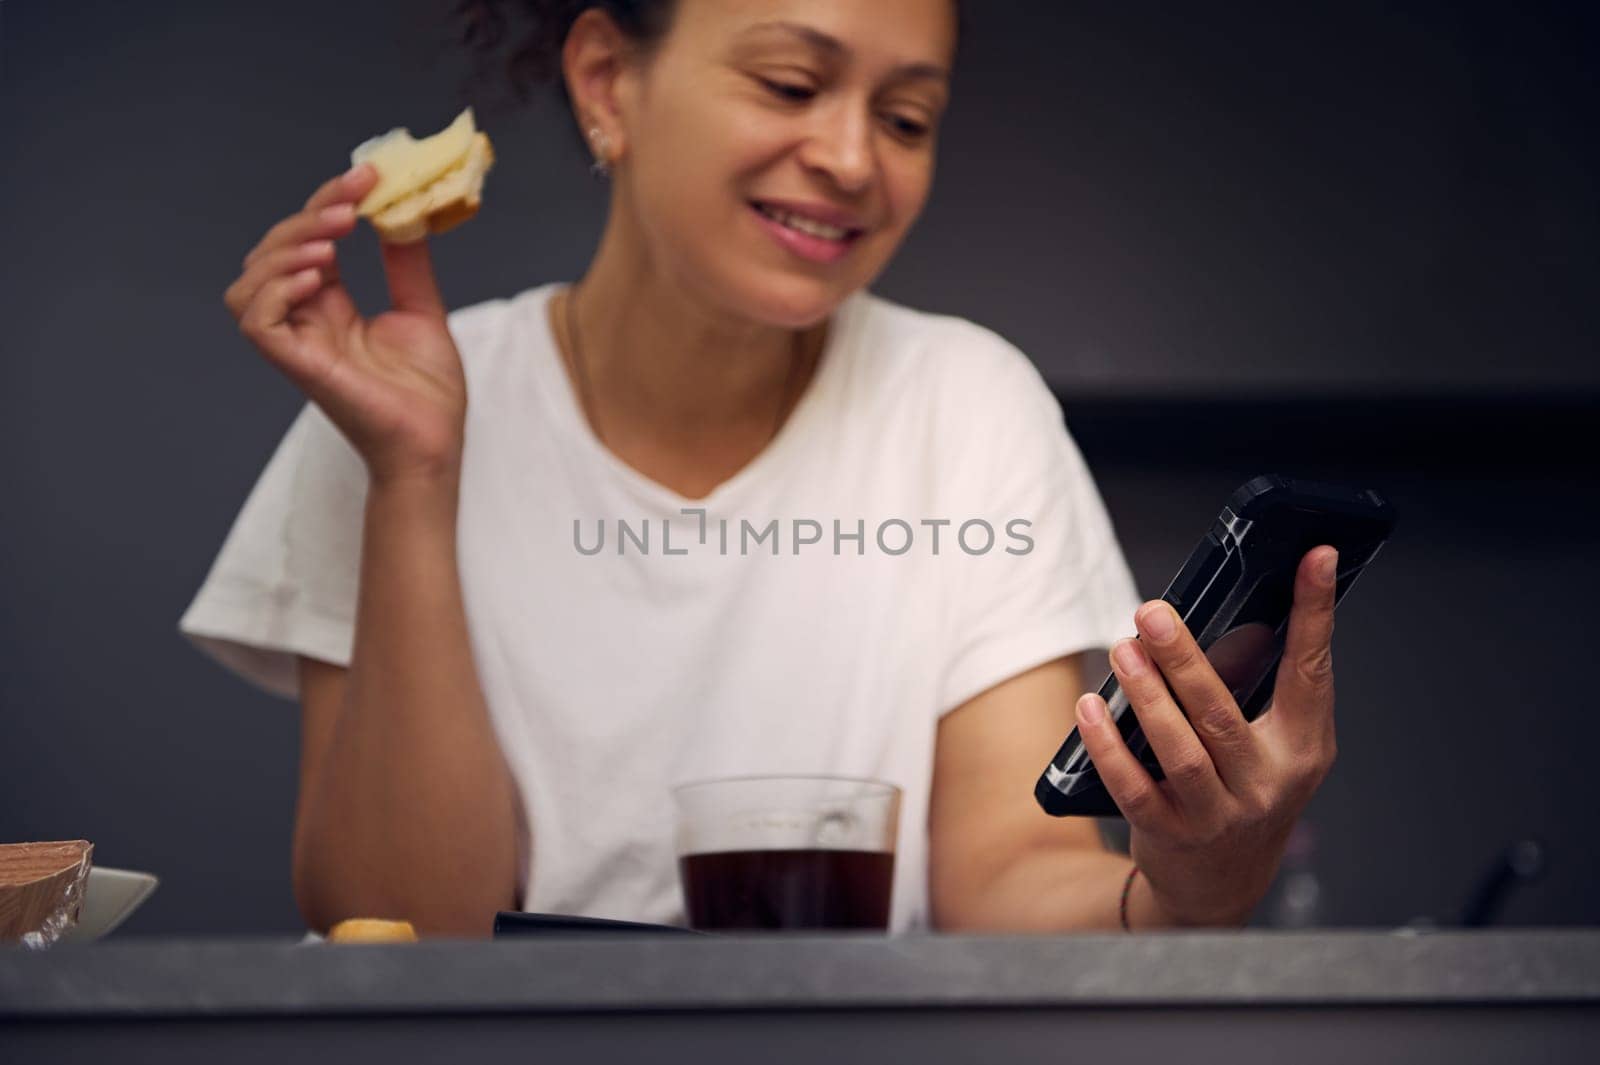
[0,929,1600,1065]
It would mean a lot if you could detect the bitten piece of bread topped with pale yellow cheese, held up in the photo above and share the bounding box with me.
[350,107,494,245]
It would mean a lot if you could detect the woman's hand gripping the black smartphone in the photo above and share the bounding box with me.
[1077,545,1338,924]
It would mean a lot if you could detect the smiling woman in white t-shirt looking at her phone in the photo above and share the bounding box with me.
[181,0,1333,935]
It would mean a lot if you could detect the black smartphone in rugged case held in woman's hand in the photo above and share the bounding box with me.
[1034,475,1395,817]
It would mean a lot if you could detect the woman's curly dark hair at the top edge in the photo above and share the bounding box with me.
[454,0,966,158]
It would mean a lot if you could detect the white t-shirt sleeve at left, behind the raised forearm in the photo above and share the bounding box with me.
[178,403,366,699]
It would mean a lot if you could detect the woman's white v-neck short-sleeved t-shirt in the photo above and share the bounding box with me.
[179,283,1139,931]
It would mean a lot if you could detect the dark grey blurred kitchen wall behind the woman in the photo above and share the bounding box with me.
[0,0,1600,934]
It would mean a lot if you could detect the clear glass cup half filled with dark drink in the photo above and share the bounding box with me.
[672,777,901,932]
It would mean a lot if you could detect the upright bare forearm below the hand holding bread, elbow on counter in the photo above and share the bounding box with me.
[294,483,517,935]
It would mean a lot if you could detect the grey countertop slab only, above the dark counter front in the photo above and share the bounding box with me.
[0,929,1600,1020]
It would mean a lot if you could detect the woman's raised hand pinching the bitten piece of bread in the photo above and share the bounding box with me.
[222,165,467,480]
